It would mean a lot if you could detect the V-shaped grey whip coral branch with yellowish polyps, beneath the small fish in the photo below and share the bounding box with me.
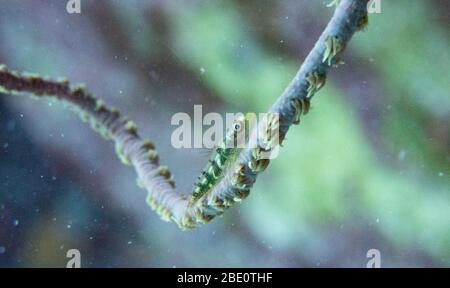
[0,0,369,229]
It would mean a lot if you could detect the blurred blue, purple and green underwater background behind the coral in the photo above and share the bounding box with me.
[0,0,450,267]
